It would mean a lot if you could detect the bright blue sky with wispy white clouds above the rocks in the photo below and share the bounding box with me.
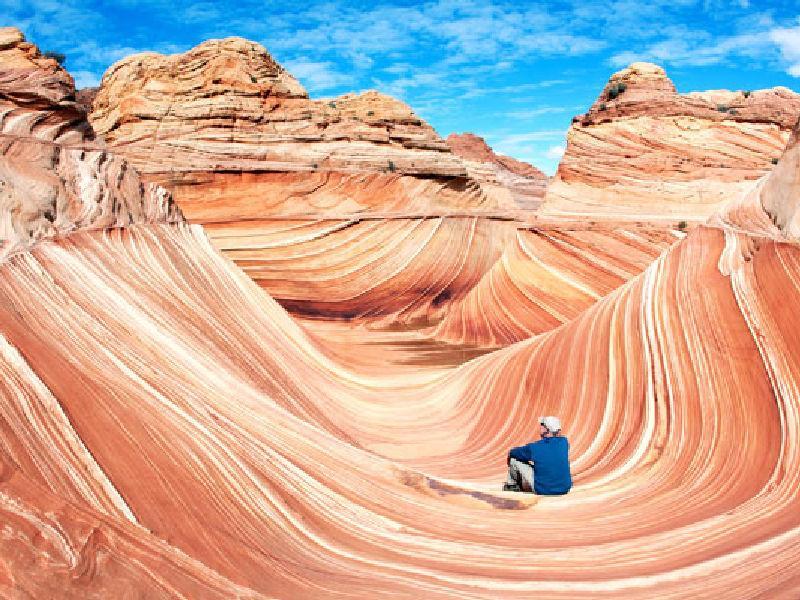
[0,0,800,173]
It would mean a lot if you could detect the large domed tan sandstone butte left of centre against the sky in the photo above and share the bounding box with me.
[91,38,497,221]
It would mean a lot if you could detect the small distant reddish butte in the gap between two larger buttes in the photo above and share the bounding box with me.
[447,133,548,210]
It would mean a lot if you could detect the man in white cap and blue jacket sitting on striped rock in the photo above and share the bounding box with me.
[503,417,572,496]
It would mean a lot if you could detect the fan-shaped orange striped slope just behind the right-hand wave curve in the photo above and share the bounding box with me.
[432,222,683,347]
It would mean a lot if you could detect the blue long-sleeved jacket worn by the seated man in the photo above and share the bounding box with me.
[509,435,572,496]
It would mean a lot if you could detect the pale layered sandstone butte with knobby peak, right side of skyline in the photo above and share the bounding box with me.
[543,63,800,219]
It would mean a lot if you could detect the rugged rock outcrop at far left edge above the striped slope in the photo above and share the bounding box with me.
[0,28,182,256]
